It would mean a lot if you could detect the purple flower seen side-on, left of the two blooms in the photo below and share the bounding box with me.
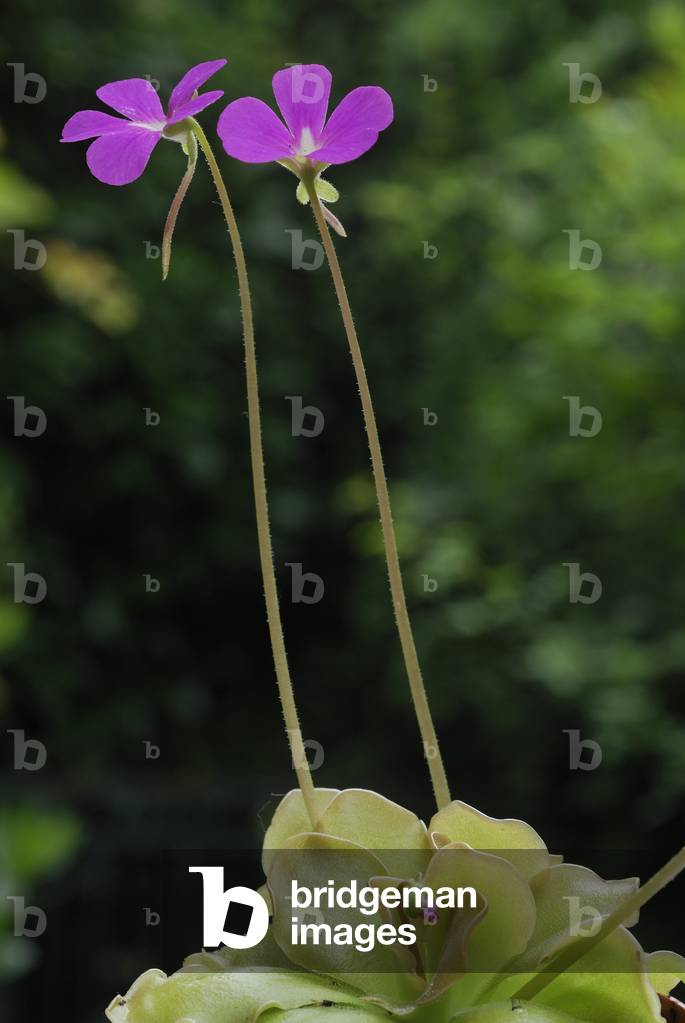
[60,60,226,185]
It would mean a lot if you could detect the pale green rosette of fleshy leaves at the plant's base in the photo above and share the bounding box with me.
[106,789,685,1023]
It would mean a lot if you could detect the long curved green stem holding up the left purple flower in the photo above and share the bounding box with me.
[189,118,317,827]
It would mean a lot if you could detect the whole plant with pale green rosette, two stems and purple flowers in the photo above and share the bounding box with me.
[62,58,685,1023]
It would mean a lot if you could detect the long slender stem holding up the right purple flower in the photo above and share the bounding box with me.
[303,173,450,809]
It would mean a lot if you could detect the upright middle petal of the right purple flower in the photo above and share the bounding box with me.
[272,64,331,149]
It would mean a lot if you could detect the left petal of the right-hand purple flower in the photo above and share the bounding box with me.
[217,96,292,164]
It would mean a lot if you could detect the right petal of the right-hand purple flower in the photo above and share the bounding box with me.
[309,85,393,164]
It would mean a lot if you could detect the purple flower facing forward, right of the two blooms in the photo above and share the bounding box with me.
[217,64,393,166]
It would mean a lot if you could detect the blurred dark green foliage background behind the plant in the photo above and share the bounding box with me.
[0,0,685,1023]
